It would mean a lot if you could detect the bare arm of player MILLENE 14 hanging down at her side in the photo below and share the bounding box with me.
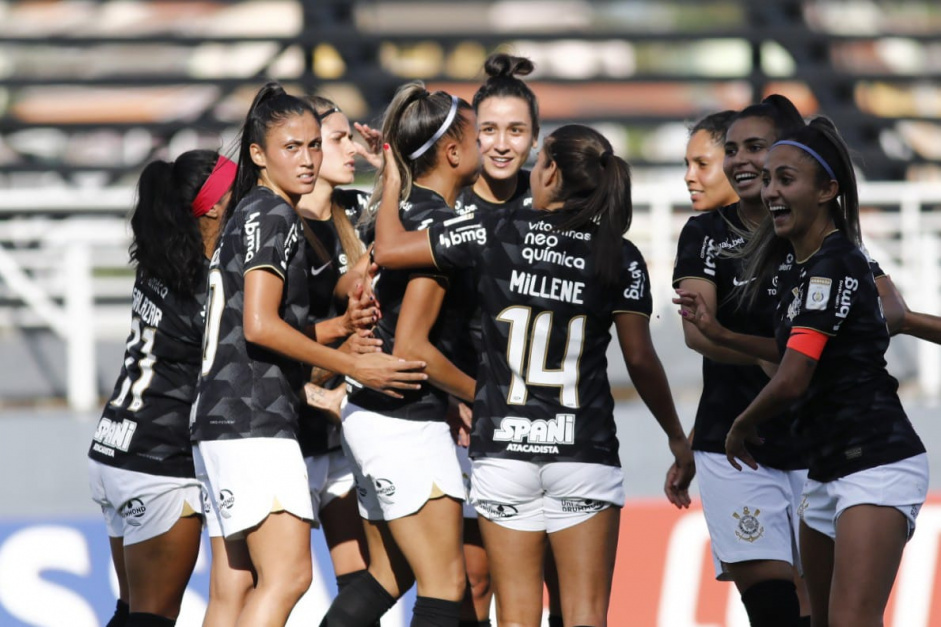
[614,312,696,507]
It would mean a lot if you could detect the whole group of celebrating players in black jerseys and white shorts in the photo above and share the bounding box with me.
[89,54,941,627]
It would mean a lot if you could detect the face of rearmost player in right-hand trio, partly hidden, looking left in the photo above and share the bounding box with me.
[684,130,738,211]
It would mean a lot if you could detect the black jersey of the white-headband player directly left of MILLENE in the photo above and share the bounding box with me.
[348,185,476,420]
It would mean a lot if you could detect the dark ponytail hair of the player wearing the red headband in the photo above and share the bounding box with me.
[128,150,219,296]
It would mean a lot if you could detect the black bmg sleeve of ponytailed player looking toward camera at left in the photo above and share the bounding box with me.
[242,199,302,279]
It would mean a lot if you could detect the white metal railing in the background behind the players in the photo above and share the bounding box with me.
[0,181,941,411]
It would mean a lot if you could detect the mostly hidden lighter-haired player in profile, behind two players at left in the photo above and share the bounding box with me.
[298,96,382,612]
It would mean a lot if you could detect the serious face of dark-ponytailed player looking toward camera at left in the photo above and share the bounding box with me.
[250,113,323,206]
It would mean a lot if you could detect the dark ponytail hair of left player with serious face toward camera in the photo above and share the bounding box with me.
[228,81,317,215]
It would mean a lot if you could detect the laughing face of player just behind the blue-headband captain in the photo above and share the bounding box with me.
[723,117,777,204]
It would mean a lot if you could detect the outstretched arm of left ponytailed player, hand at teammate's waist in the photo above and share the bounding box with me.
[242,268,428,397]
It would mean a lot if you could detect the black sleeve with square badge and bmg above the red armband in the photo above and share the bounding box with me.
[791,258,869,335]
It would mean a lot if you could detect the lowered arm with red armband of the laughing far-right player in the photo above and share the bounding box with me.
[725,344,827,470]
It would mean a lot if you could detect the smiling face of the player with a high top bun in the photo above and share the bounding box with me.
[477,96,536,180]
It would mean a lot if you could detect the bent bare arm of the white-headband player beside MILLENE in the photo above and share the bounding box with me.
[393,276,475,402]
